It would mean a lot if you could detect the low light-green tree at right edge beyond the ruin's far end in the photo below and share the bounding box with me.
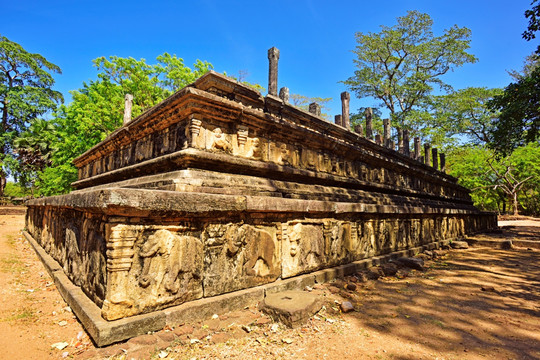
[448,143,540,215]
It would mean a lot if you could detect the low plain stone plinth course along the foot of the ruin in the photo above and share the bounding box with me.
[23,231,480,347]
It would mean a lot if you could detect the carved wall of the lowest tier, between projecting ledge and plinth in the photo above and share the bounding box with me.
[27,197,496,320]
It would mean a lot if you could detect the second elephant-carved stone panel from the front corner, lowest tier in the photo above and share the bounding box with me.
[203,224,281,296]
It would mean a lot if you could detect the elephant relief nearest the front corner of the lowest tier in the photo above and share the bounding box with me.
[139,229,203,294]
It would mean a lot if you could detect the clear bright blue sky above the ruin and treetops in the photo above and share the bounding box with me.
[0,0,537,114]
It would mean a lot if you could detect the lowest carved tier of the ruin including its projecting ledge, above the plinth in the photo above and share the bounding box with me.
[23,189,496,320]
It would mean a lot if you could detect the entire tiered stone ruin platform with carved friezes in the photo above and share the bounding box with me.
[26,51,497,346]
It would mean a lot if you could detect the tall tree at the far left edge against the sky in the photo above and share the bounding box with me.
[0,36,63,196]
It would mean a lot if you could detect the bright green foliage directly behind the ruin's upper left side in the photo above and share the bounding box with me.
[38,53,212,195]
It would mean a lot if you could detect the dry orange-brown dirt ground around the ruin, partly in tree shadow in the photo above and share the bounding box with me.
[0,210,540,360]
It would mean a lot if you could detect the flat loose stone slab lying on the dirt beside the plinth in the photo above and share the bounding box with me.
[260,290,323,328]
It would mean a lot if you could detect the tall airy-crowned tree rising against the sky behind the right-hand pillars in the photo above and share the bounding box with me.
[344,11,476,130]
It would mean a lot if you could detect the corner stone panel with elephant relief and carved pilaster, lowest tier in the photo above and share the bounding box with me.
[102,225,203,320]
